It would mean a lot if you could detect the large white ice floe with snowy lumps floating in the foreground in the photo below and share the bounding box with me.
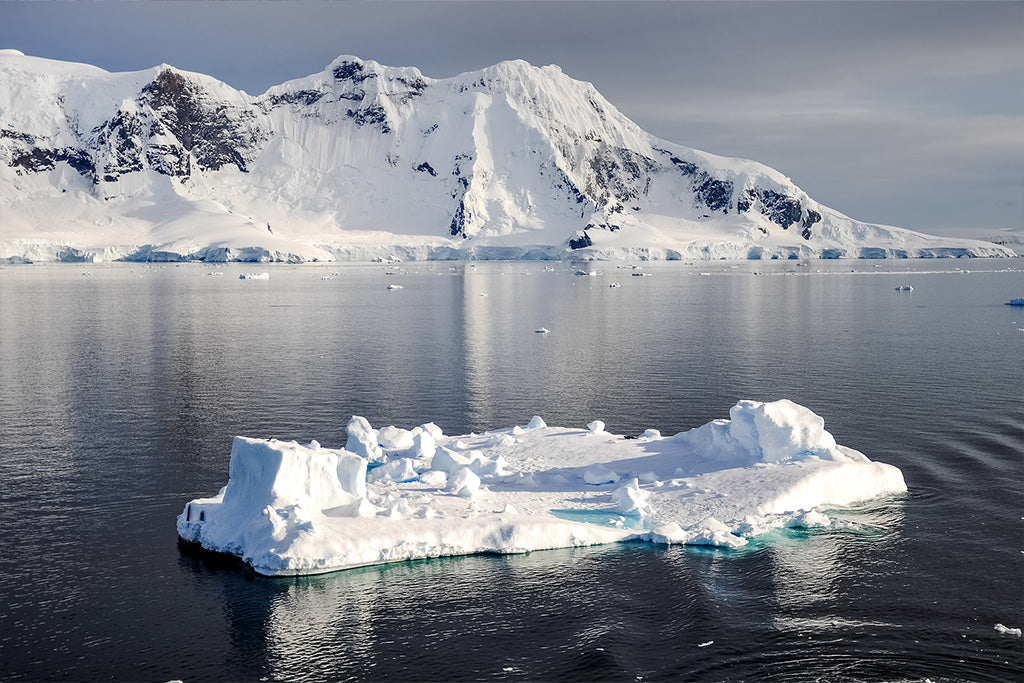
[177,400,906,575]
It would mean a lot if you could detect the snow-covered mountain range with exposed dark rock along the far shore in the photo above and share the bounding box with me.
[0,50,1013,261]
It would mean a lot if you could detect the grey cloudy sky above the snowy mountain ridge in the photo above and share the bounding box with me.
[0,0,1024,237]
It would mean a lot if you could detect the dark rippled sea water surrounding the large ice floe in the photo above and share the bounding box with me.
[0,259,1024,681]
